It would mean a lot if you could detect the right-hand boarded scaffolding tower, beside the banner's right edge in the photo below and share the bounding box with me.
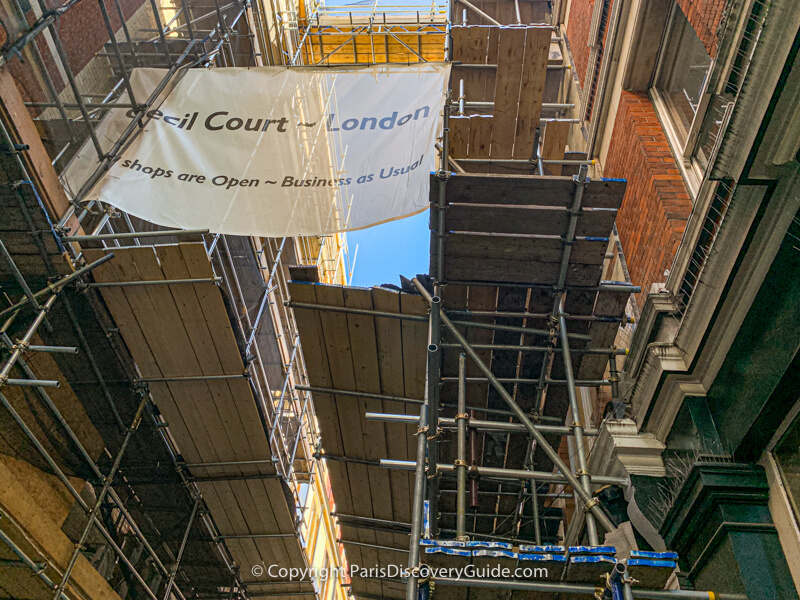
[290,0,743,600]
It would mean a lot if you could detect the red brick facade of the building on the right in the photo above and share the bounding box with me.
[566,0,726,307]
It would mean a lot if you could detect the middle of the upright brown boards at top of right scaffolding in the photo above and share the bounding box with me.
[490,28,525,158]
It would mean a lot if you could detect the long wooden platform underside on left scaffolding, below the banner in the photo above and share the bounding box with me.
[86,244,304,584]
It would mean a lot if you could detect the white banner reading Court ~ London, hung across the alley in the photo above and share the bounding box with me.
[64,64,449,237]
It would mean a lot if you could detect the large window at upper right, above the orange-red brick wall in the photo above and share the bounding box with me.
[655,5,711,146]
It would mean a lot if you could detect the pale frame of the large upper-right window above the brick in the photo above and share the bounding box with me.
[649,1,716,197]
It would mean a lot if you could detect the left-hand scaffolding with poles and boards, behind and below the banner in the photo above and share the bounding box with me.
[0,0,352,600]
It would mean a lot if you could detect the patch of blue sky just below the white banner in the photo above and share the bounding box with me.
[347,211,430,287]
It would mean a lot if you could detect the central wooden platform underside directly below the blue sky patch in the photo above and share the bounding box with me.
[289,282,427,598]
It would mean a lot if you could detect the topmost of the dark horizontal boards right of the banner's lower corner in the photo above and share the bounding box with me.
[431,173,627,209]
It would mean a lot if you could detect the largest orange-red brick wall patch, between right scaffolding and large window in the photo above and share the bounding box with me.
[603,92,692,307]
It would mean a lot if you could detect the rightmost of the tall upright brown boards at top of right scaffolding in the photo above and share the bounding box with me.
[514,27,551,159]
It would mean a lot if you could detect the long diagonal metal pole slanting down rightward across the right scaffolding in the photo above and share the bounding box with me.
[408,278,615,532]
